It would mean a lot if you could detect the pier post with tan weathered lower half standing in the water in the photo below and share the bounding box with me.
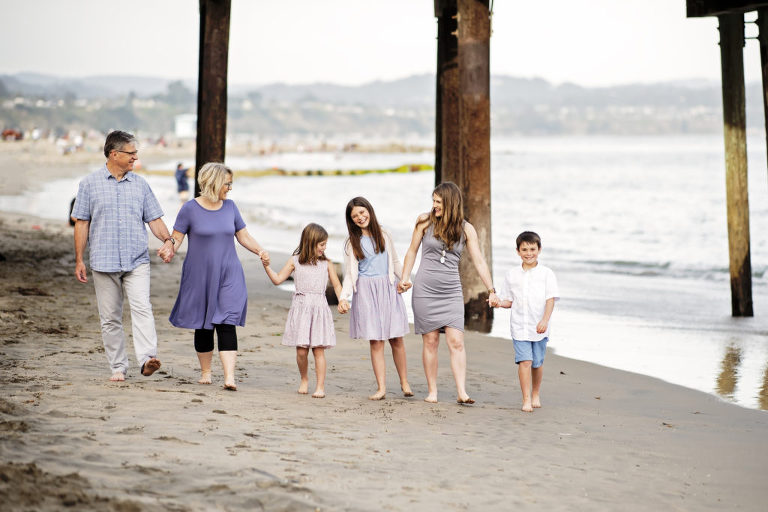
[717,13,753,316]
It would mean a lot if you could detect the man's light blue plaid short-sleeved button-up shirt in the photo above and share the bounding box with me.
[72,164,163,272]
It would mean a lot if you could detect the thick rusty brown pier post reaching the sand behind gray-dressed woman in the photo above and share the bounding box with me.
[456,0,493,332]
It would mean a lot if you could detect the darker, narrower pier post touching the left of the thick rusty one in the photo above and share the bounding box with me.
[435,0,459,186]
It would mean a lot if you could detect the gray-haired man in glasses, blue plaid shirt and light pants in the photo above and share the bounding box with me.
[72,130,173,381]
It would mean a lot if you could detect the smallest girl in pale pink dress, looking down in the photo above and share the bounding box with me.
[262,224,343,398]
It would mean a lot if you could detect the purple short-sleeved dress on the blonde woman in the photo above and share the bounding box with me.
[169,199,248,329]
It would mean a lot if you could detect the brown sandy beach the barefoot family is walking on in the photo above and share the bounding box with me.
[0,142,768,511]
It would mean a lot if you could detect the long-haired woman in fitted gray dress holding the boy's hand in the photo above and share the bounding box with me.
[398,181,497,404]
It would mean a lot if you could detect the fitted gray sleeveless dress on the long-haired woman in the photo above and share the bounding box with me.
[411,222,466,334]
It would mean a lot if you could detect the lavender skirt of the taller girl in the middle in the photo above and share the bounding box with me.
[349,276,408,340]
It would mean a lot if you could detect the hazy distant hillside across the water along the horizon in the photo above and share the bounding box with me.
[0,73,763,137]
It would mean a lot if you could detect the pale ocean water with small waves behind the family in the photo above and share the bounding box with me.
[0,136,768,410]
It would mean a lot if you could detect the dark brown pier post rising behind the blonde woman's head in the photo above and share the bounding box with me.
[195,0,231,197]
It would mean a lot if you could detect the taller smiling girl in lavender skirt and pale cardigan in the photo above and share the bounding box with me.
[339,197,413,400]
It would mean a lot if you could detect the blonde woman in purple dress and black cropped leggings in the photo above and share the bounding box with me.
[170,163,269,391]
